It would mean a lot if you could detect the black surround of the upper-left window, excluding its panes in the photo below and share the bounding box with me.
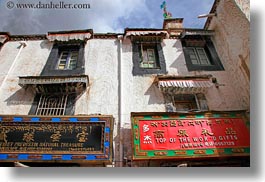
[41,41,85,76]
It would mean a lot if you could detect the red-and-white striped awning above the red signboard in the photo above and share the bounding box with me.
[158,79,214,94]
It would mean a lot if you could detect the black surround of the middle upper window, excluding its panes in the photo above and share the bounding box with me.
[132,41,167,76]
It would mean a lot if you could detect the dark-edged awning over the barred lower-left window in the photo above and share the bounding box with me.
[18,75,89,93]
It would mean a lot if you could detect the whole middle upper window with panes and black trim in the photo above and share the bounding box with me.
[133,40,166,75]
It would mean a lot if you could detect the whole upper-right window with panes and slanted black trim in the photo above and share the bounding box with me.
[182,36,224,71]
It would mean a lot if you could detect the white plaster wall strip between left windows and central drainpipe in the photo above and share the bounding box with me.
[75,39,118,116]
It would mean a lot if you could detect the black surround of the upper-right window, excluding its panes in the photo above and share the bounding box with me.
[181,35,224,71]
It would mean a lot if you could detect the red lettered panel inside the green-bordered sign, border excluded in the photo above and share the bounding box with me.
[139,118,250,150]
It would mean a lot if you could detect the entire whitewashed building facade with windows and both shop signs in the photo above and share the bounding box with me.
[0,0,250,167]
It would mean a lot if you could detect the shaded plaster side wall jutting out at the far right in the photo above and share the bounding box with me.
[209,1,250,109]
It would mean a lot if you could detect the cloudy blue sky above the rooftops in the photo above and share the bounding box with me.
[0,0,214,35]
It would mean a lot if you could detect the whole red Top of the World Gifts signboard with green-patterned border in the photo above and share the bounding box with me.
[132,111,250,160]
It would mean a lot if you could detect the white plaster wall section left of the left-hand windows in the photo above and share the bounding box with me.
[0,40,52,115]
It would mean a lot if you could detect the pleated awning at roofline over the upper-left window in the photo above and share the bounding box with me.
[47,33,91,41]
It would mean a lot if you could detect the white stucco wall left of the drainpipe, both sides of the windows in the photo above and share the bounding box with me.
[0,39,118,121]
